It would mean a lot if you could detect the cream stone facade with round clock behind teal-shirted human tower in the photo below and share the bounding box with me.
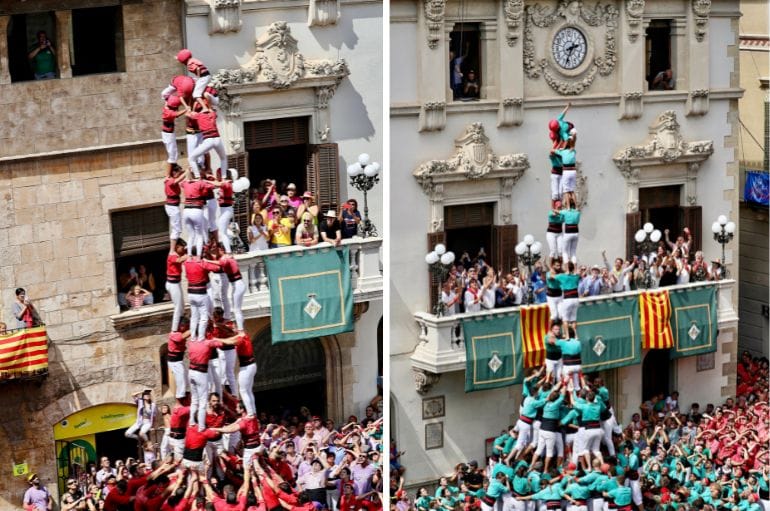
[390,0,742,487]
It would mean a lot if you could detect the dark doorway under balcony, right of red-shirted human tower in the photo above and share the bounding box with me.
[252,327,328,418]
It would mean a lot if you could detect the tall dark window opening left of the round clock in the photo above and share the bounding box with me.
[449,23,483,101]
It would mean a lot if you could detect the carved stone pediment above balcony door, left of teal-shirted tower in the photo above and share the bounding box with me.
[413,122,529,232]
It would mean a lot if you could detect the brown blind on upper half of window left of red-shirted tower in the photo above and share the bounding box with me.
[112,206,169,259]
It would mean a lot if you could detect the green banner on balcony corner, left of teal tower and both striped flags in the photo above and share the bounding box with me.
[463,311,524,392]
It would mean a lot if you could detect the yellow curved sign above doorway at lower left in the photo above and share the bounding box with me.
[53,403,136,440]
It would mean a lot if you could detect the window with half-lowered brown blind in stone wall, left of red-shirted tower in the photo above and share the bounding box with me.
[112,206,170,310]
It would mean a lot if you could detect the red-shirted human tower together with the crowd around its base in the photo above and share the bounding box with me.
[45,49,382,511]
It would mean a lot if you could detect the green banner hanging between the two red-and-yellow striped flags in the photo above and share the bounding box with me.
[577,296,641,373]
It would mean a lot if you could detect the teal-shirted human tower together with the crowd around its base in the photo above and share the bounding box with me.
[391,105,770,511]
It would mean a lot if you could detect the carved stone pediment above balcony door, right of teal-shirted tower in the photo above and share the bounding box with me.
[612,110,714,213]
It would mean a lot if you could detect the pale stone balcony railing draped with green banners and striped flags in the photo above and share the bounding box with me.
[411,280,738,376]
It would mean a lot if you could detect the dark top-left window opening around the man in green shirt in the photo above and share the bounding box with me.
[8,12,59,82]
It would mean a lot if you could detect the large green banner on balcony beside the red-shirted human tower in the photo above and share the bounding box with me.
[265,247,353,344]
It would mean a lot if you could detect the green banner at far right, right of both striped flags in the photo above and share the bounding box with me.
[669,285,717,359]
